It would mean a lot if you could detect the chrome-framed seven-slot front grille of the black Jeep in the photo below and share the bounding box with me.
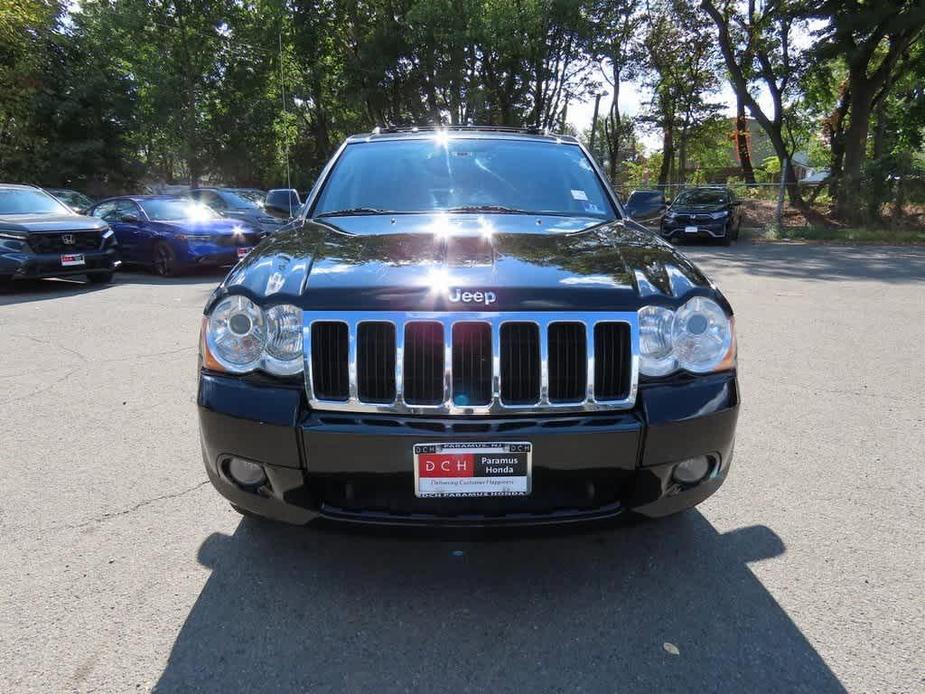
[303,312,639,415]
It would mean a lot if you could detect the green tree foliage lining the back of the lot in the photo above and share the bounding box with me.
[0,0,925,226]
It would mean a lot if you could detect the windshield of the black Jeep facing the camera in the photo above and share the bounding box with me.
[314,137,614,219]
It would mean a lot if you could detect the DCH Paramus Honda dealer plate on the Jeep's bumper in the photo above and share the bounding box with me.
[414,441,533,498]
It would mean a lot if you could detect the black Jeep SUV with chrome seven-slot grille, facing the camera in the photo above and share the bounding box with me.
[198,128,739,525]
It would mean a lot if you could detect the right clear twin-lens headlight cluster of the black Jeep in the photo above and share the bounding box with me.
[639,296,735,376]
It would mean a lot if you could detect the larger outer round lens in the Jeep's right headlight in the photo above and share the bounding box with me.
[671,296,732,373]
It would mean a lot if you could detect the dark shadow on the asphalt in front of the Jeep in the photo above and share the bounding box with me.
[155,511,844,694]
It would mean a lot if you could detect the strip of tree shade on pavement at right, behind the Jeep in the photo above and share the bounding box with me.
[680,242,925,284]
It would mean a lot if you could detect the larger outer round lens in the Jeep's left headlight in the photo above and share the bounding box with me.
[206,296,267,373]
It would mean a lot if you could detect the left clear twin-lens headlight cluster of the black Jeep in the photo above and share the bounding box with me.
[205,295,302,376]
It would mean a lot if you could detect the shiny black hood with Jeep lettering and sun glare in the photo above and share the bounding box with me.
[215,214,725,311]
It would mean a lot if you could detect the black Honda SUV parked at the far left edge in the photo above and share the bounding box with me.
[0,183,116,283]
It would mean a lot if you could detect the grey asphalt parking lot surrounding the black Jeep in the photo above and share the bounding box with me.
[0,244,925,692]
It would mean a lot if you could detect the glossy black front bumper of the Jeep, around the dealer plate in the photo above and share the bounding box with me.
[198,372,739,526]
